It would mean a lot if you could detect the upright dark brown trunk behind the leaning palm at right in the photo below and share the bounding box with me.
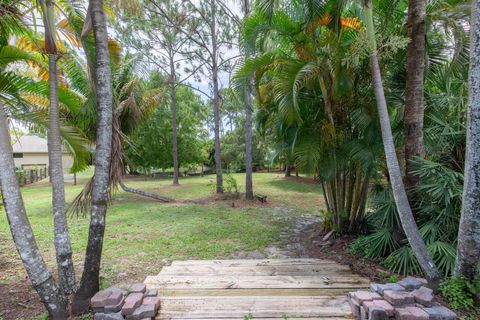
[404,0,426,193]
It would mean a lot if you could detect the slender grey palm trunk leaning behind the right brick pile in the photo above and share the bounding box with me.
[364,0,440,289]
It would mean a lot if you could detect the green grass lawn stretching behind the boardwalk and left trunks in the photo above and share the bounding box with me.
[0,172,323,286]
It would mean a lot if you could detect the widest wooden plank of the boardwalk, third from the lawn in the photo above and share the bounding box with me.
[144,275,368,289]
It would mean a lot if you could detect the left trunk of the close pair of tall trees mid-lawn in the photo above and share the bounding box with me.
[210,0,223,193]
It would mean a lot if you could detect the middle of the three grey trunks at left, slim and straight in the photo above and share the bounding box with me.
[48,54,75,295]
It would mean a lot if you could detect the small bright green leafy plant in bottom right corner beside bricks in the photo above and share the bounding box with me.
[440,276,480,310]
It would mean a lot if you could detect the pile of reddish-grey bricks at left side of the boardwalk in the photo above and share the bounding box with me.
[91,283,160,320]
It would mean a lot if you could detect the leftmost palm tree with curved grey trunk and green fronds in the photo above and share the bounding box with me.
[0,1,67,319]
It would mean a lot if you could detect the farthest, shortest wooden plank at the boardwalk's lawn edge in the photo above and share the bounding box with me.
[171,258,337,267]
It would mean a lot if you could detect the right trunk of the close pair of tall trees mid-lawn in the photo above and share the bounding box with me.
[243,0,253,200]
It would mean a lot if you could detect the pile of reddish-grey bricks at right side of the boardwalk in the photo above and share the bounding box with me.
[348,277,456,320]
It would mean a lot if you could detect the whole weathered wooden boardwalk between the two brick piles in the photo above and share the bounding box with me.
[145,259,369,320]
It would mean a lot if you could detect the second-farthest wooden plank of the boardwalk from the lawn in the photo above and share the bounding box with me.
[158,264,352,276]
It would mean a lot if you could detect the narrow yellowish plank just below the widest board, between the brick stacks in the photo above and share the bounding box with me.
[156,286,358,297]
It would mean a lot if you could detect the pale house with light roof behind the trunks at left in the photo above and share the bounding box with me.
[12,135,73,172]
